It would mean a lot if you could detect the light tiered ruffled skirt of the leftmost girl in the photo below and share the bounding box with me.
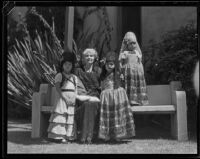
[47,93,77,140]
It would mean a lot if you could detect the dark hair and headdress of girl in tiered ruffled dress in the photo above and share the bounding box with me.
[60,51,76,73]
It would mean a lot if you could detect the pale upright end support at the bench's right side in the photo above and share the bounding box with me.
[171,91,188,141]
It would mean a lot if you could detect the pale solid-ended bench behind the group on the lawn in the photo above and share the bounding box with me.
[31,81,188,141]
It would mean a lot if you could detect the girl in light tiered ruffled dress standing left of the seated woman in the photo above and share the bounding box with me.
[48,52,90,142]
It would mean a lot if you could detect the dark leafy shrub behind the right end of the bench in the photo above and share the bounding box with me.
[143,22,198,135]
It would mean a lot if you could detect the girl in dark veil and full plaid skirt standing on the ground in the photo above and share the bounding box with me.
[99,52,135,141]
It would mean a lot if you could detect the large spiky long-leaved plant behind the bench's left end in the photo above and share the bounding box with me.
[8,10,63,108]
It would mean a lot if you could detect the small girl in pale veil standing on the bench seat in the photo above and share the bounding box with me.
[119,32,148,105]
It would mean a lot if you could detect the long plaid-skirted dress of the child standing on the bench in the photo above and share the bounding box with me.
[121,52,149,105]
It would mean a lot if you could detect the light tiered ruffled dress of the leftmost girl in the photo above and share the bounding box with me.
[48,73,77,140]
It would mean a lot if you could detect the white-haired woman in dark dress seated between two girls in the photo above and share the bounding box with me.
[75,49,101,144]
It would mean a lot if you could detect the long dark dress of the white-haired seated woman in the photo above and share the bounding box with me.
[75,67,100,142]
